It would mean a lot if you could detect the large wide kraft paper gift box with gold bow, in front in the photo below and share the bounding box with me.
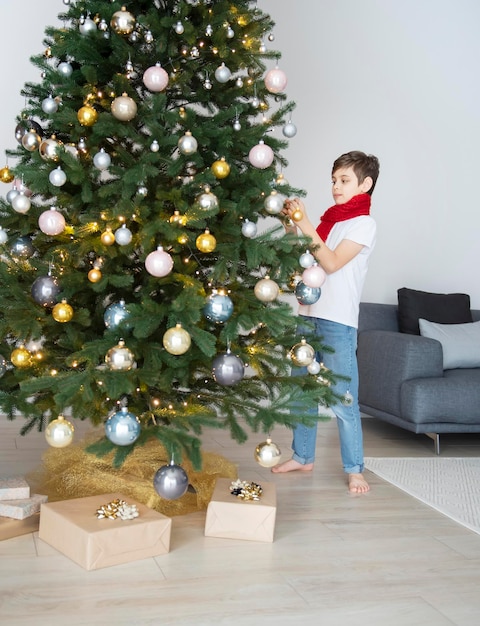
[38,493,172,570]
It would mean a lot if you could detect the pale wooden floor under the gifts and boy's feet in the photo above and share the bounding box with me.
[0,410,480,626]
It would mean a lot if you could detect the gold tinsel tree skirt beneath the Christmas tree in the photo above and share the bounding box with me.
[28,439,237,517]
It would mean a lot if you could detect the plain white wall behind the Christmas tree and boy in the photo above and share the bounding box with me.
[0,0,480,308]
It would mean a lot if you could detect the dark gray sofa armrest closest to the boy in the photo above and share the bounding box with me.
[357,330,443,417]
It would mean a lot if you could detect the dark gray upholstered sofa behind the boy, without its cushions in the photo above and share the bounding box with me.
[357,302,480,454]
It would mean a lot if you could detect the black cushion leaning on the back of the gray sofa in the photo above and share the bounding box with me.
[397,287,472,335]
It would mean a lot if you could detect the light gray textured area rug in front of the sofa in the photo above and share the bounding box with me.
[365,457,480,534]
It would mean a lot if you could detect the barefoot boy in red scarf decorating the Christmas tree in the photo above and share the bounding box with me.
[272,151,380,494]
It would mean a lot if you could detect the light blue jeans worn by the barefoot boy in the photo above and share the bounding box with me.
[292,317,363,474]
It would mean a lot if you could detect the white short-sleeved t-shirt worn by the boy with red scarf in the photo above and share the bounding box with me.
[299,215,377,328]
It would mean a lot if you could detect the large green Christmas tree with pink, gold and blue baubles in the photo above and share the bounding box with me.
[0,0,338,476]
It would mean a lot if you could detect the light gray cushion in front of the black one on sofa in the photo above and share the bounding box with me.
[418,318,480,370]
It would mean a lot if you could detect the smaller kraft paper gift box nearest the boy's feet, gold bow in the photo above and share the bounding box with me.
[205,478,277,541]
